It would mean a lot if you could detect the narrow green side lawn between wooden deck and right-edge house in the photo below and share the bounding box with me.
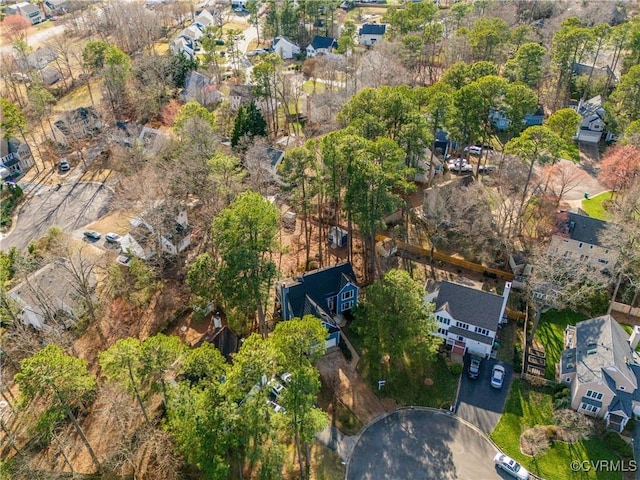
[535,310,587,380]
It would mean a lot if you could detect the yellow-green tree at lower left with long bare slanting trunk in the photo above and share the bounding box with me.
[14,345,102,472]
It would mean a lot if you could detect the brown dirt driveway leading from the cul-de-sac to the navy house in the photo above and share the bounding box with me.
[316,350,384,425]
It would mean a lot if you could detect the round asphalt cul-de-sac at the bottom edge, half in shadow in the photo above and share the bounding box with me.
[346,408,503,480]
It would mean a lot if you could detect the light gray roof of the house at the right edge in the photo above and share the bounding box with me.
[576,315,637,386]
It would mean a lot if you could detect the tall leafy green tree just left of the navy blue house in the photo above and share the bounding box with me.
[212,192,279,336]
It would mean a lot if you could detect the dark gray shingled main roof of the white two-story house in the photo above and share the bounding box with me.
[436,282,503,332]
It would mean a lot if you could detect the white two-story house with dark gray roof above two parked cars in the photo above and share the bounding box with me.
[425,282,511,358]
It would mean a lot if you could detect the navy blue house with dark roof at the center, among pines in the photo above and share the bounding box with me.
[276,262,359,348]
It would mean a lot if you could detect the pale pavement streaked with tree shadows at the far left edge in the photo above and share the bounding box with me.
[0,182,112,250]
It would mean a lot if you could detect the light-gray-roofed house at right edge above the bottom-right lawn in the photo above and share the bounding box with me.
[557,315,640,432]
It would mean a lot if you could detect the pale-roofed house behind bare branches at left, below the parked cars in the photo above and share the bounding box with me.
[8,259,96,330]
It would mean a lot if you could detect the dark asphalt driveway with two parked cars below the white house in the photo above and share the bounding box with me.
[456,355,513,435]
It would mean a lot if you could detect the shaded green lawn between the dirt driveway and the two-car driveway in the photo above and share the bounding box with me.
[345,327,460,408]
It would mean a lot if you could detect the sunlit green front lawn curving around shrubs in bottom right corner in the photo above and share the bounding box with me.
[491,380,621,480]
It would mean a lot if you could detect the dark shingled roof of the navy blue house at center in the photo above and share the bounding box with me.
[287,263,356,317]
